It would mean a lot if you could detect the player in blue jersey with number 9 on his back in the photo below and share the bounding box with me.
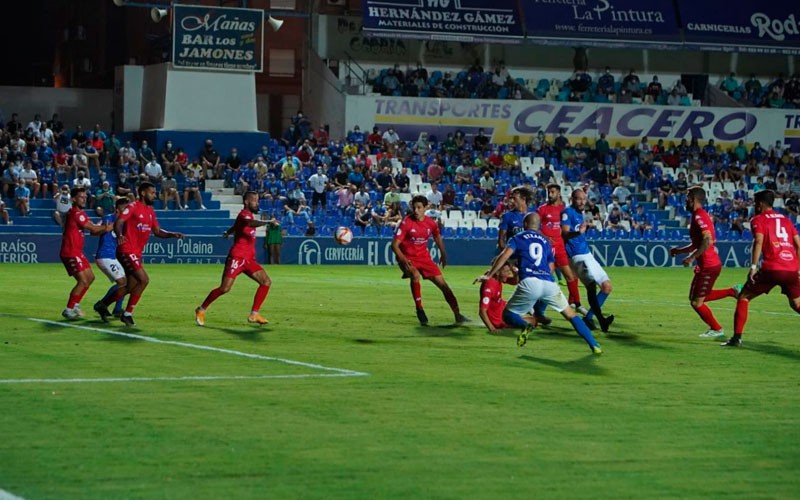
[478,212,603,354]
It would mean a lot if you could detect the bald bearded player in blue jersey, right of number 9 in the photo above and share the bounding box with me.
[561,189,614,332]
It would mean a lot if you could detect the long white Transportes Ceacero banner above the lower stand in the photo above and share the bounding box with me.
[346,96,800,153]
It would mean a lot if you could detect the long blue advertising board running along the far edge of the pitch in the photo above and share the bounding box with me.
[0,234,750,267]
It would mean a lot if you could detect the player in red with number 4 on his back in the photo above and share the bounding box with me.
[722,190,800,347]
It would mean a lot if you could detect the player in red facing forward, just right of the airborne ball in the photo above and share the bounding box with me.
[392,195,469,326]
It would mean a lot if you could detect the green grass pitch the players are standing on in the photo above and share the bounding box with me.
[0,265,800,500]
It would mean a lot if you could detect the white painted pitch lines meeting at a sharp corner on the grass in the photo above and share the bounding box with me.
[0,313,369,384]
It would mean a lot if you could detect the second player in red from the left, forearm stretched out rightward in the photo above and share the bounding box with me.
[94,182,183,326]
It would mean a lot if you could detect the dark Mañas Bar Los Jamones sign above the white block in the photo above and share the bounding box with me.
[172,5,264,71]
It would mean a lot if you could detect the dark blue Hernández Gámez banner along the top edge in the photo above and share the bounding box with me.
[361,0,522,43]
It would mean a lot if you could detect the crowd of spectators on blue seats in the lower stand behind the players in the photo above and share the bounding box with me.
[0,107,800,237]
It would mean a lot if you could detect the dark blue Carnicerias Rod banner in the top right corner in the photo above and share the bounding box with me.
[678,0,800,55]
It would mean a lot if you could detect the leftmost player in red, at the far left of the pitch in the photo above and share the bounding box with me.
[59,187,113,319]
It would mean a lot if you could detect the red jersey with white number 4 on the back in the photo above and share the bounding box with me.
[750,210,797,272]
